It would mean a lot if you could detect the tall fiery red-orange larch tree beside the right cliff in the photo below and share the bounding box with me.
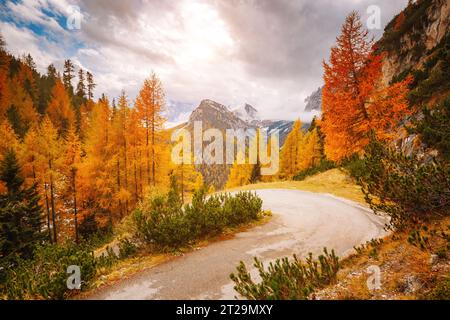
[321,12,411,161]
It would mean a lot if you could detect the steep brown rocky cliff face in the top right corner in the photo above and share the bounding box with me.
[378,0,450,85]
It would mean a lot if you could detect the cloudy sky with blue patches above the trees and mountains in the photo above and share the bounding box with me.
[0,0,407,119]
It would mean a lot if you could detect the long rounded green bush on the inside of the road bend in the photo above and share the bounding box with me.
[133,185,262,250]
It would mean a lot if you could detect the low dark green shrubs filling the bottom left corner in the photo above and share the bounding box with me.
[0,235,127,299]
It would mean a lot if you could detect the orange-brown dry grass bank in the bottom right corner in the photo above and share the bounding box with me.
[315,218,450,300]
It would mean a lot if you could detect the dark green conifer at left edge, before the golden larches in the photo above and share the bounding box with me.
[0,150,45,259]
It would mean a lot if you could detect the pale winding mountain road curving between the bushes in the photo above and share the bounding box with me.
[90,189,386,299]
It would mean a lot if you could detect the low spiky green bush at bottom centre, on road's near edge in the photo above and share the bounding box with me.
[230,248,339,300]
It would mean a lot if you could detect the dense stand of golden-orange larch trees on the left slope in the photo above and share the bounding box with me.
[0,37,186,243]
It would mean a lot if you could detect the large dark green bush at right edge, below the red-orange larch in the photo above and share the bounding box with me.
[357,140,450,228]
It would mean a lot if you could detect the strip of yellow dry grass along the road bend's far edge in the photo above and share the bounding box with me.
[227,169,366,205]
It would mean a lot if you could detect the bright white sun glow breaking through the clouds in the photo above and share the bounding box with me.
[175,1,234,65]
